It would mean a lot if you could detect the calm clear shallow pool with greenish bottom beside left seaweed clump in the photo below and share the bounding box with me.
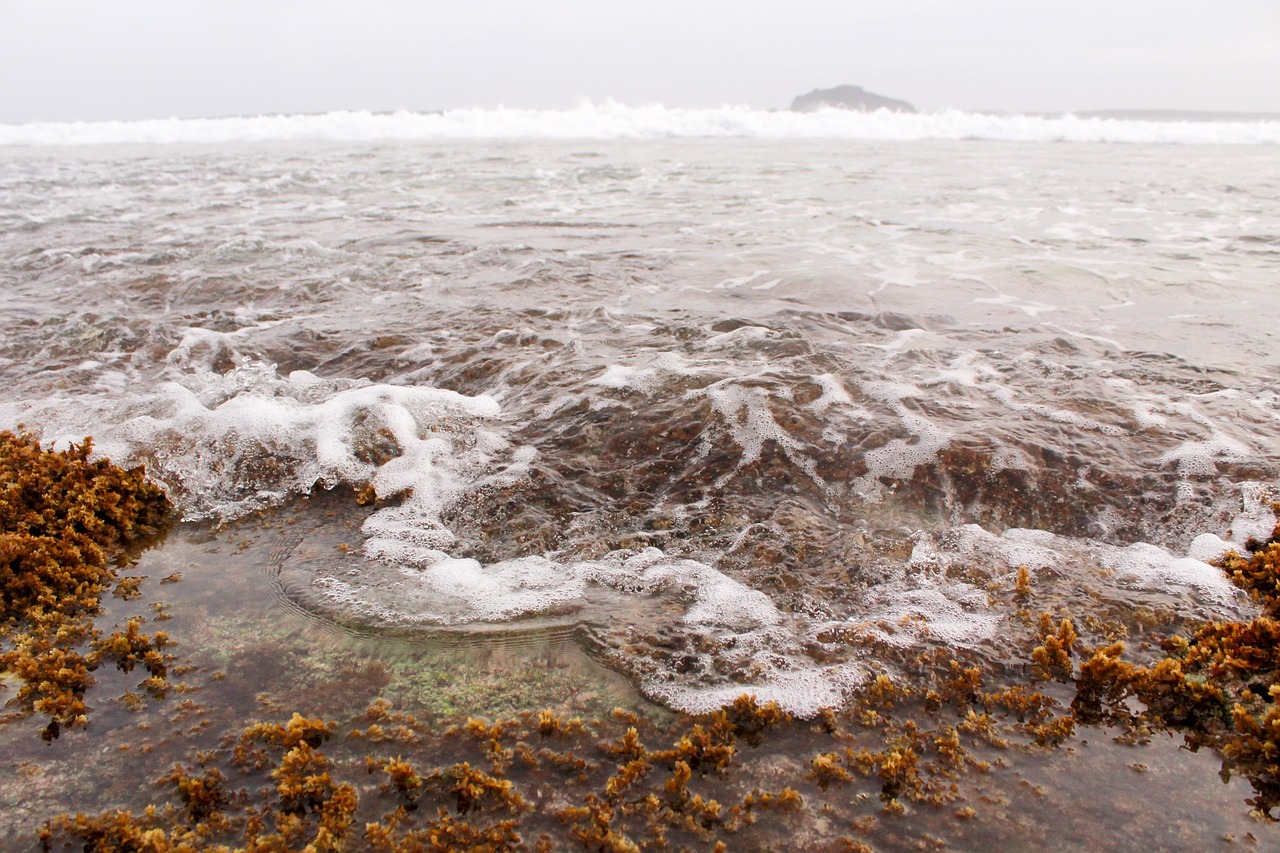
[0,500,634,849]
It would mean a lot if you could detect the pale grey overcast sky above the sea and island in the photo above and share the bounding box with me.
[0,0,1280,123]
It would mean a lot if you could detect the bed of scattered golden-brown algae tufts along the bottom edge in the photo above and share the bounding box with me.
[35,604,1265,853]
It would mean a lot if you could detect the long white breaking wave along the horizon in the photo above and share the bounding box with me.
[0,101,1280,145]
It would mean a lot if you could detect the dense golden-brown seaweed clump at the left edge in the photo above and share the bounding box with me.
[0,430,170,739]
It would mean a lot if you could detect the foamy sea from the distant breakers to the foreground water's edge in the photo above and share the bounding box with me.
[0,104,1280,845]
